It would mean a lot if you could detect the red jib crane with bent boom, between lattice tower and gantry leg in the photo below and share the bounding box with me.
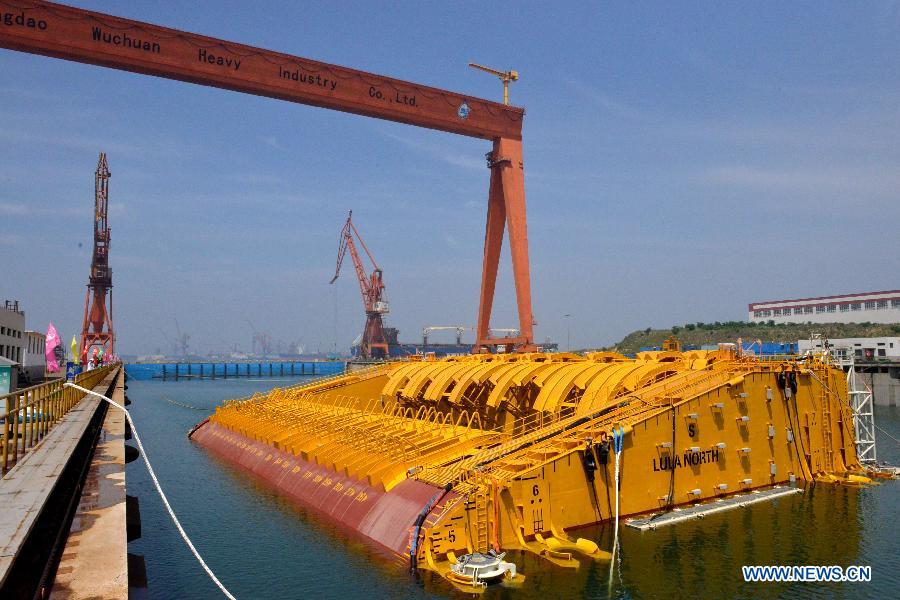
[330,210,388,359]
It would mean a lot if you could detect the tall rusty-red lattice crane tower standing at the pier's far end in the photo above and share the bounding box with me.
[81,152,116,362]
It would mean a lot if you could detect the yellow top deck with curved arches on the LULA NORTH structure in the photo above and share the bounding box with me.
[213,353,804,489]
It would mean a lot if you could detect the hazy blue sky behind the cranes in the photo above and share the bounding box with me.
[0,1,900,353]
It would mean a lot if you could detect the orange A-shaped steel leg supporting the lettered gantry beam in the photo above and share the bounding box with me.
[475,138,534,352]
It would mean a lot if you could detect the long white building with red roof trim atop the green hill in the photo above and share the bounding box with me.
[747,290,900,323]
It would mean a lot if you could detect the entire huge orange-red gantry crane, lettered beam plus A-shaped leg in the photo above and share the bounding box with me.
[0,0,533,350]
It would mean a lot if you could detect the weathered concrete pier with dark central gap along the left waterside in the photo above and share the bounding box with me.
[0,368,128,598]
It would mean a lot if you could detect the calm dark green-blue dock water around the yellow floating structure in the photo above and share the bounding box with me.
[127,379,900,600]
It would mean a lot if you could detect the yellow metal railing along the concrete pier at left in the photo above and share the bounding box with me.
[0,364,120,475]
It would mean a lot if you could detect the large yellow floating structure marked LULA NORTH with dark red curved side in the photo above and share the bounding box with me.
[193,349,868,577]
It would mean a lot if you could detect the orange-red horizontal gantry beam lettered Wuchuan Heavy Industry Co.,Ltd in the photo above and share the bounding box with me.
[0,0,525,139]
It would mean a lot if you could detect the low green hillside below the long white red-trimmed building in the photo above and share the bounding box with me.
[609,321,900,353]
